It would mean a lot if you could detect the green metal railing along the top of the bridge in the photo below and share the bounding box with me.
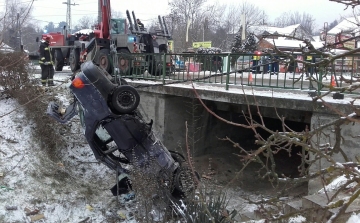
[114,53,360,93]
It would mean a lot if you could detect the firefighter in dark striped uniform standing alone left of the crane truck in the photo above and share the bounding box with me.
[39,35,55,86]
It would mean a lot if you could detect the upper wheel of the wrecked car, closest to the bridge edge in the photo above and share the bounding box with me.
[111,85,140,114]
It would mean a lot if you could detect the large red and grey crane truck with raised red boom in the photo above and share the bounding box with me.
[37,0,172,75]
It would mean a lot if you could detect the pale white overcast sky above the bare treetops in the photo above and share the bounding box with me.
[0,0,358,28]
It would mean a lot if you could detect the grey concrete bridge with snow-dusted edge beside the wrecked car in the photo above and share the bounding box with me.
[129,80,360,193]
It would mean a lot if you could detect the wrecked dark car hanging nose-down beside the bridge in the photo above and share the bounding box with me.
[47,61,196,201]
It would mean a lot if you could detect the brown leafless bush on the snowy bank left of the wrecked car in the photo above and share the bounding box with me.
[0,52,67,161]
